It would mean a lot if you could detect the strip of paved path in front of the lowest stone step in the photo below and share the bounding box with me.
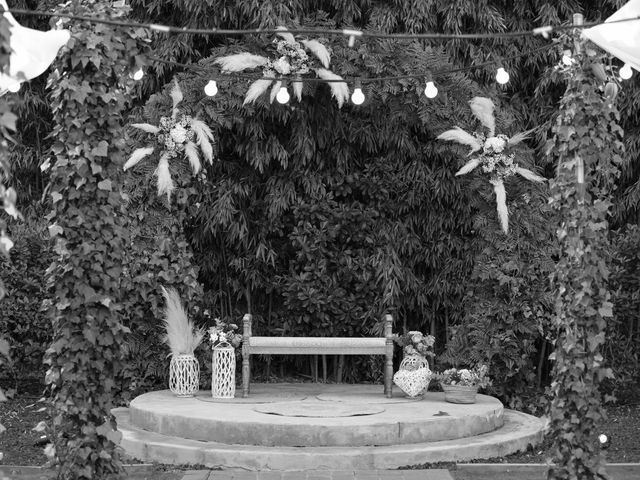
[182,469,453,480]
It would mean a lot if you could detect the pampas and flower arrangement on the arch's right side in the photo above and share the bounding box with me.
[437,97,545,233]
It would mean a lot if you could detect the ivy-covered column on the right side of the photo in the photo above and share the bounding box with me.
[548,26,623,480]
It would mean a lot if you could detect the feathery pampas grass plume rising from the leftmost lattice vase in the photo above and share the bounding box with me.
[161,287,205,357]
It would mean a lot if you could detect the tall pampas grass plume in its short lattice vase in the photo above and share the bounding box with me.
[161,287,205,397]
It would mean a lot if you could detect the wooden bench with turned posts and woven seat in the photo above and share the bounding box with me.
[242,314,393,398]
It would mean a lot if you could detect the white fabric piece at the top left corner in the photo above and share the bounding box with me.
[0,0,71,90]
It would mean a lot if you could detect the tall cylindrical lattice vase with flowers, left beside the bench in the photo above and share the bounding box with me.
[205,312,242,398]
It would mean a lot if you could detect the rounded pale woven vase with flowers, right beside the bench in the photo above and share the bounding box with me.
[393,331,435,397]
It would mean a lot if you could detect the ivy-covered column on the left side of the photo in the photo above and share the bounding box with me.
[45,0,146,479]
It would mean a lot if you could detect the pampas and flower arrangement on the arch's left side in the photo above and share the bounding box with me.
[124,82,213,201]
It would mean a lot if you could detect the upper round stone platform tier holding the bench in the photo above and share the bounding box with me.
[129,384,504,447]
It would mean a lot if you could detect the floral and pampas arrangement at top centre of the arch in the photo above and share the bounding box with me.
[215,27,349,107]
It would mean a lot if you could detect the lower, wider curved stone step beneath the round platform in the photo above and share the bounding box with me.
[114,408,544,471]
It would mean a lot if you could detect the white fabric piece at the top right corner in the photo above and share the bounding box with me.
[582,0,640,72]
